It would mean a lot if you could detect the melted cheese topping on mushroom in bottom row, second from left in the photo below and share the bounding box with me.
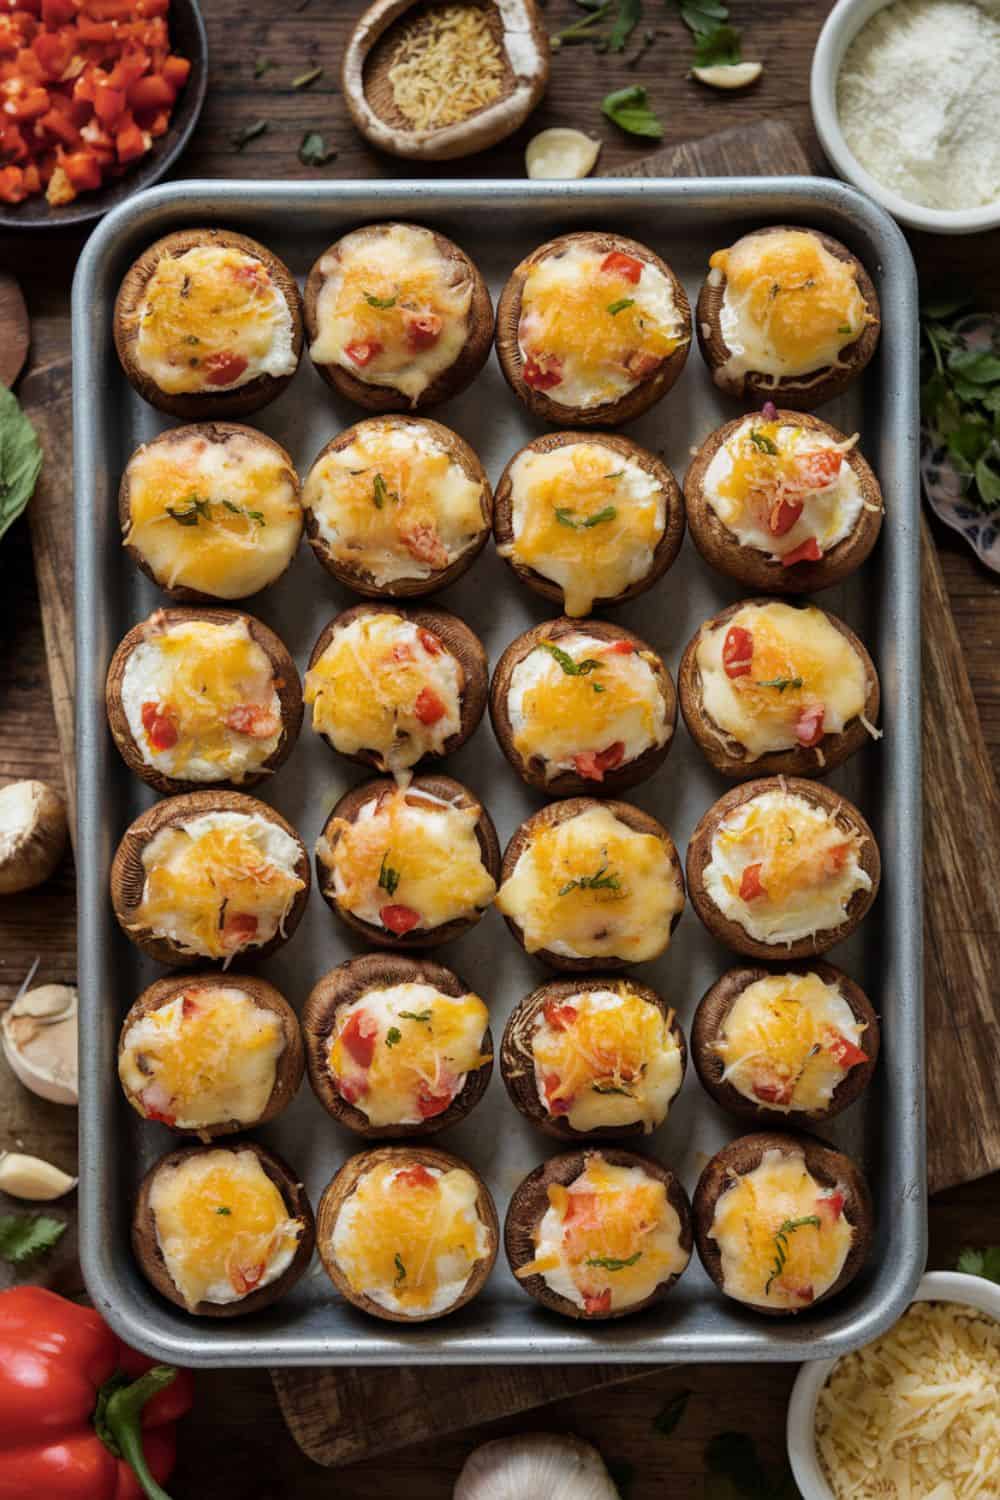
[331,1163,489,1317]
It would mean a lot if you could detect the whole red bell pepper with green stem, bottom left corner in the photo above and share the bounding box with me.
[0,1287,193,1500]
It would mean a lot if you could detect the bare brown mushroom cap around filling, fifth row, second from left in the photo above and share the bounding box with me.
[303,953,493,1140]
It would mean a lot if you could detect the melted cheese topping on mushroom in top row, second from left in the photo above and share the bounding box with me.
[309,224,472,404]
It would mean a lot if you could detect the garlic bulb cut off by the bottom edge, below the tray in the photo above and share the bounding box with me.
[453,1433,619,1500]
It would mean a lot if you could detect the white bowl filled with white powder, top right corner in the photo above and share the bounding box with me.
[810,0,1000,234]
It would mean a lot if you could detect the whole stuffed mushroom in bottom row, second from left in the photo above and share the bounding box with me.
[318,1146,499,1323]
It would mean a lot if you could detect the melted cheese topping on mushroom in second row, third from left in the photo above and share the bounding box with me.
[498,441,667,617]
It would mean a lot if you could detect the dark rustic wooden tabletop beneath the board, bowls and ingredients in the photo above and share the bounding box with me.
[0,0,1000,1500]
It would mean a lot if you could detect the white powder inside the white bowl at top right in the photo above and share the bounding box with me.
[837,0,1000,209]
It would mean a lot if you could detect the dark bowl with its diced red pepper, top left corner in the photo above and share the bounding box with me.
[0,0,208,228]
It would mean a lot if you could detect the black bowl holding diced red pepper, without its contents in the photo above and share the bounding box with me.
[0,0,208,230]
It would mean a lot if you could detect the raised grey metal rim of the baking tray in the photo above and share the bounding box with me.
[72,176,927,1368]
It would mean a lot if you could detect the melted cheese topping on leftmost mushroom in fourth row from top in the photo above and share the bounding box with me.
[129,813,306,963]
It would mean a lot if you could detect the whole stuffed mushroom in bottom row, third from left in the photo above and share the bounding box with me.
[504,1146,693,1320]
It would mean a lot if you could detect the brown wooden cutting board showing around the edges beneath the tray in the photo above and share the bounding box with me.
[19,122,1000,1466]
